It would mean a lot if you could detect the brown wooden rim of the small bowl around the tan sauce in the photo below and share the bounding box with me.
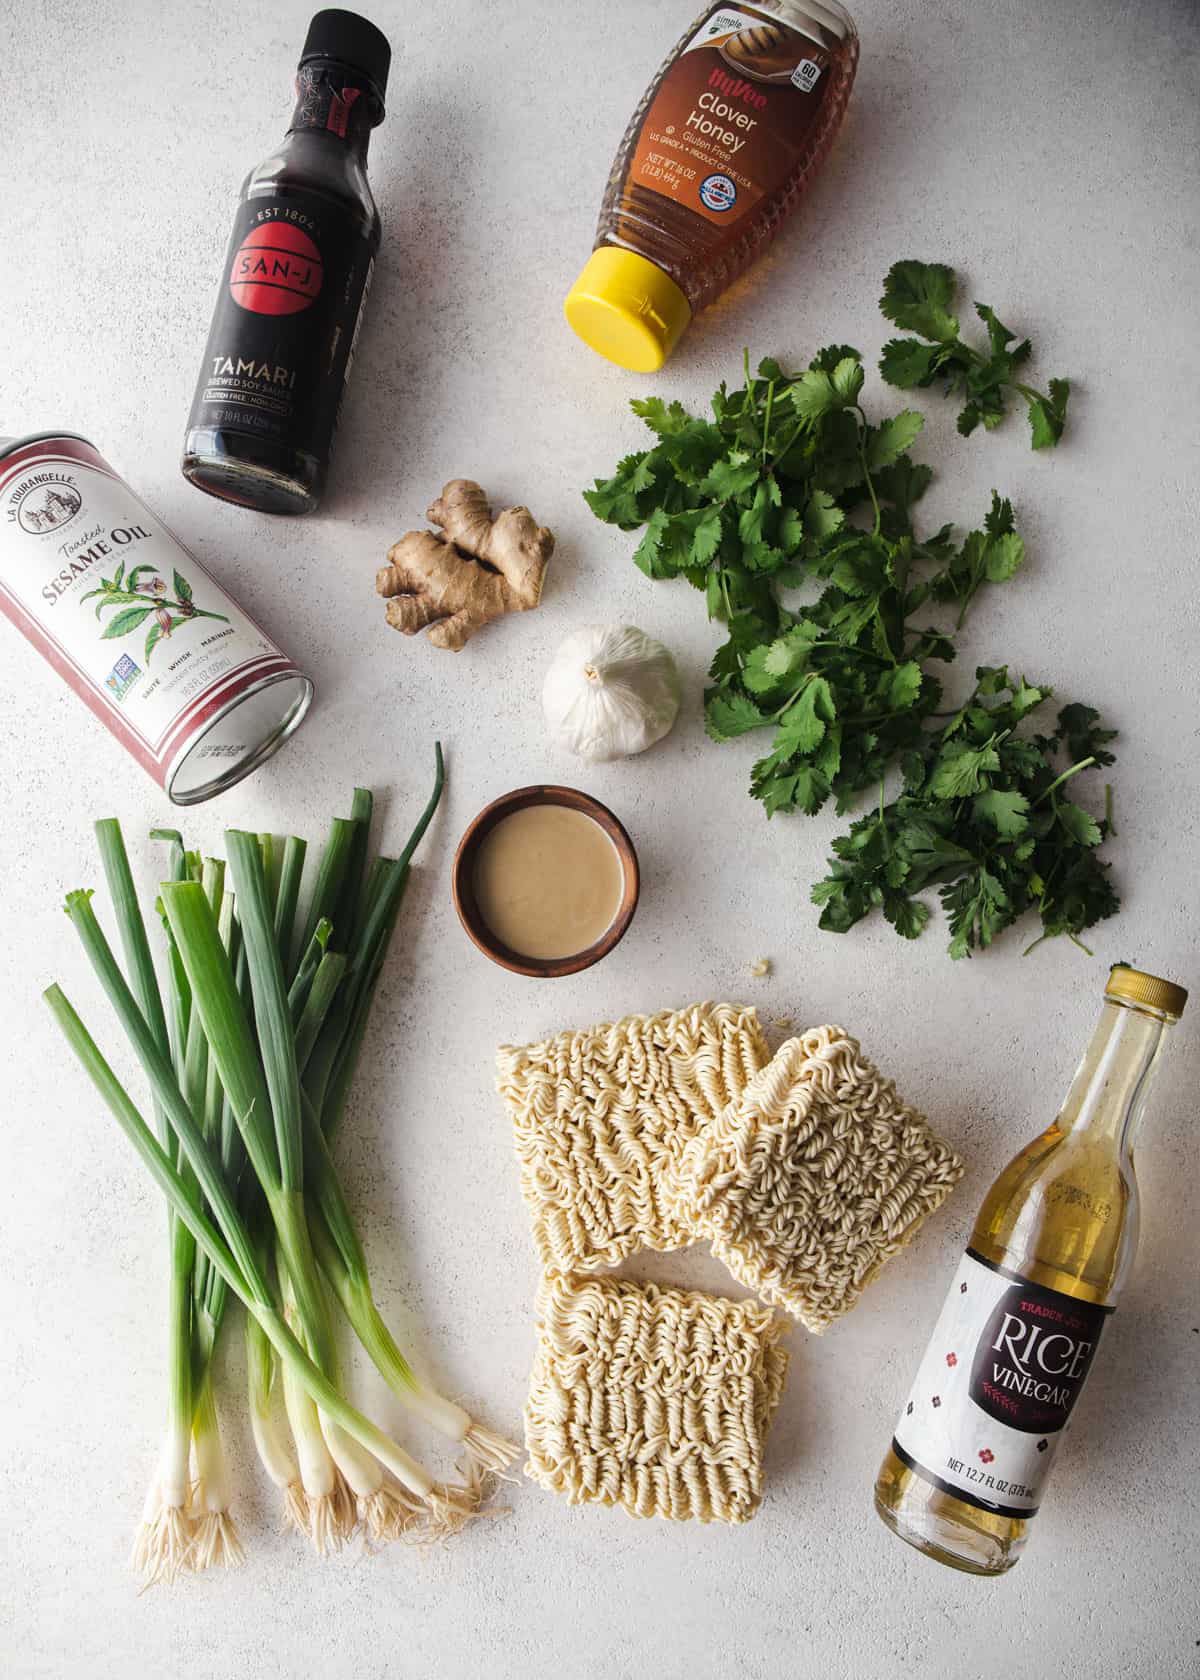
[450,786,642,979]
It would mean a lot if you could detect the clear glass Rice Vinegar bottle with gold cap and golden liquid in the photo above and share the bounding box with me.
[876,964,1187,1574]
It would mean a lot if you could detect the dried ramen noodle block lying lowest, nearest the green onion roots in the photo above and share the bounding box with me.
[524,1275,788,1522]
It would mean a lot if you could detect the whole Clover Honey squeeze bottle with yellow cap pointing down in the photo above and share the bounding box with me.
[566,0,859,373]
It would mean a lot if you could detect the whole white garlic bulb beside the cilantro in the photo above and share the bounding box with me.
[541,625,679,759]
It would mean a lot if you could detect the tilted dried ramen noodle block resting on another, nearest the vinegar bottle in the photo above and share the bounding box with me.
[671,1026,963,1331]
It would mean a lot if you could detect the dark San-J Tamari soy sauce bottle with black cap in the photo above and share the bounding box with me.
[183,10,392,514]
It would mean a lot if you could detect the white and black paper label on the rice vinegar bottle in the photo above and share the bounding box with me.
[892,1248,1111,1517]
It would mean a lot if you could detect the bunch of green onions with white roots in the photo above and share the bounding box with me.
[45,744,516,1583]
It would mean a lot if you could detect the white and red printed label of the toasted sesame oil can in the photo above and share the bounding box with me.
[0,437,294,783]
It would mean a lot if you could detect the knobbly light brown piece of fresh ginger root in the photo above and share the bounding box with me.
[375,479,555,654]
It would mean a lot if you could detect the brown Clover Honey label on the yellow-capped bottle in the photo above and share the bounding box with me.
[629,7,834,230]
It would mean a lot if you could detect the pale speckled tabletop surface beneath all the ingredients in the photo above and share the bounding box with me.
[0,0,1200,1680]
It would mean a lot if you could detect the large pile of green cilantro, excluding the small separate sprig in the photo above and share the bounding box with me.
[585,264,1118,956]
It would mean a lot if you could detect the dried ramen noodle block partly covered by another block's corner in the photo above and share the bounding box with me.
[496,1003,770,1272]
